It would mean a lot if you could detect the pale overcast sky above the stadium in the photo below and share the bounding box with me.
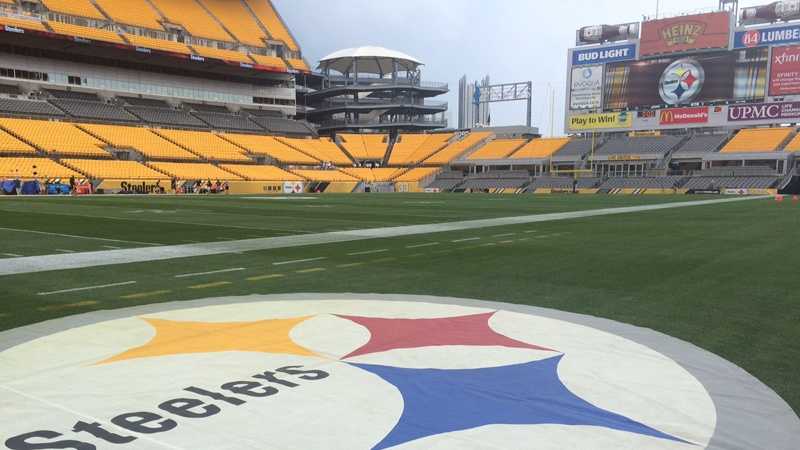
[273,0,770,134]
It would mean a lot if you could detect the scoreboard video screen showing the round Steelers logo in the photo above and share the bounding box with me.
[603,48,769,110]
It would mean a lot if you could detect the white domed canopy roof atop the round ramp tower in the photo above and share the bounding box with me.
[319,46,423,75]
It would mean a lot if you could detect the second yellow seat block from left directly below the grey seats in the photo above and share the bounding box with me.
[80,124,198,160]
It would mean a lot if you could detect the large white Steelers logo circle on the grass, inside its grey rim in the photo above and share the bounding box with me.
[0,294,796,450]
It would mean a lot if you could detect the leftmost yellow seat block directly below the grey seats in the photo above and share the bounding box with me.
[0,119,111,158]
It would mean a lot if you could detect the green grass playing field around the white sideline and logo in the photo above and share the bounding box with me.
[0,194,800,411]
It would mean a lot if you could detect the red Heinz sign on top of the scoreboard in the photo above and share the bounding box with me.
[639,12,731,57]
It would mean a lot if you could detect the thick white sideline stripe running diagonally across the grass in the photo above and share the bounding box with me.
[0,196,772,275]
